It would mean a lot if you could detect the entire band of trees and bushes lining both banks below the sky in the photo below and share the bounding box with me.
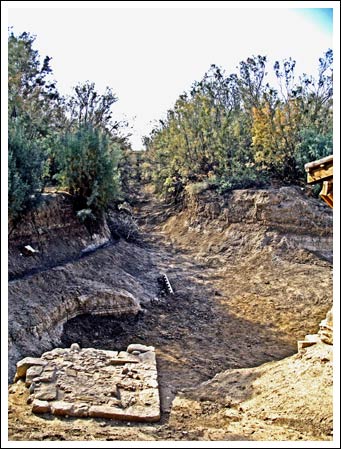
[8,28,333,222]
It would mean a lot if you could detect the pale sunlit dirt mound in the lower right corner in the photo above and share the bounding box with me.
[169,343,333,440]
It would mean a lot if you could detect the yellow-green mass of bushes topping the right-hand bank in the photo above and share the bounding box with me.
[145,50,333,199]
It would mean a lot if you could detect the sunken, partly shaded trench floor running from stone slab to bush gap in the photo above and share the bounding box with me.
[57,187,328,412]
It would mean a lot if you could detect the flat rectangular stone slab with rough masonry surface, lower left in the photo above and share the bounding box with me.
[15,343,160,422]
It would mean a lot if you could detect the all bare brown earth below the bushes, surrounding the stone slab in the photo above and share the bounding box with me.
[9,187,333,441]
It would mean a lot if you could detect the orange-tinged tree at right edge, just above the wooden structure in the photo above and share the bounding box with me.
[252,50,333,182]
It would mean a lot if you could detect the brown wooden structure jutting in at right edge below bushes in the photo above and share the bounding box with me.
[304,155,333,208]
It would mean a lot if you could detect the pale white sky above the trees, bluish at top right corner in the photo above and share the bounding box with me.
[3,1,338,150]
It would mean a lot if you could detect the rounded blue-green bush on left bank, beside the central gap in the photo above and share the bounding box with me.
[53,81,130,208]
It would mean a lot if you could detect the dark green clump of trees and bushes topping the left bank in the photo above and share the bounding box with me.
[8,32,129,222]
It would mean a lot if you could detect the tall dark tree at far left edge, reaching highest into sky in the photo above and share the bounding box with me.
[8,32,59,222]
